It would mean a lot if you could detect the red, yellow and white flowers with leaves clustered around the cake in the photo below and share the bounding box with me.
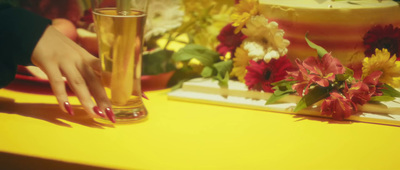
[173,0,400,120]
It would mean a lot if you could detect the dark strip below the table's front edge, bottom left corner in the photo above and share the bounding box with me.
[0,152,109,170]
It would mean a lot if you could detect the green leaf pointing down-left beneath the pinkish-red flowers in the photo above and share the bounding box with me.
[294,86,330,112]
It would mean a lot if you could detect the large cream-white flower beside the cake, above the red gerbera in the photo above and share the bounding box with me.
[242,15,290,62]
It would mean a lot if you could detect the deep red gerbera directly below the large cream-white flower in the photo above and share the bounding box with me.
[244,56,293,92]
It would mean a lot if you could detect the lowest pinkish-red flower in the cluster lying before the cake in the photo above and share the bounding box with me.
[321,92,357,120]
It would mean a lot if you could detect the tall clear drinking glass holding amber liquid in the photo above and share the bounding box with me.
[91,0,147,122]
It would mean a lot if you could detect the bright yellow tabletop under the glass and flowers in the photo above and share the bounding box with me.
[0,89,400,170]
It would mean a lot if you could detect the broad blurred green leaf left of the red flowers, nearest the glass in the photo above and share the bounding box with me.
[172,44,220,66]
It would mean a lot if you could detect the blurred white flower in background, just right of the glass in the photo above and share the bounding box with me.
[144,0,184,41]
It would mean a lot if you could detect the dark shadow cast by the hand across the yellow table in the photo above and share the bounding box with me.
[0,98,114,129]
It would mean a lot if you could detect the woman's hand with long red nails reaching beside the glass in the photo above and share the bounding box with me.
[31,26,115,122]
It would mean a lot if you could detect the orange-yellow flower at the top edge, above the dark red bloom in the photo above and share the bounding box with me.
[231,0,259,34]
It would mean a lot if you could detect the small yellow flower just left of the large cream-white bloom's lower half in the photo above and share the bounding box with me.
[231,47,251,82]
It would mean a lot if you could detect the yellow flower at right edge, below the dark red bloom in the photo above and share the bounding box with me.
[362,49,400,88]
